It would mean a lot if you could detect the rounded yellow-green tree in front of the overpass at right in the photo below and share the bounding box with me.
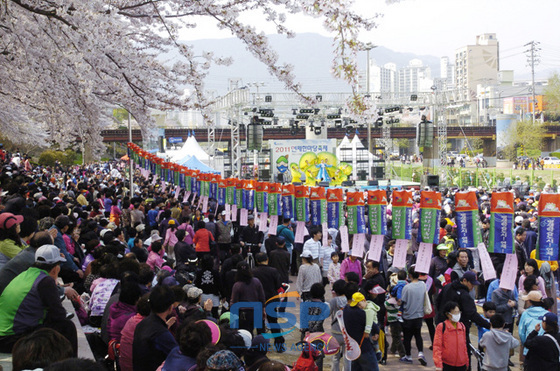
[504,120,546,161]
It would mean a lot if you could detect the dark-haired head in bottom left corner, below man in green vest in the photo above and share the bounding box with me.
[12,328,72,371]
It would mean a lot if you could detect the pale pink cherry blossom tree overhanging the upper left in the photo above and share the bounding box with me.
[0,0,375,158]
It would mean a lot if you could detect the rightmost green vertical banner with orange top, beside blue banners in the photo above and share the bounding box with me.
[418,191,441,244]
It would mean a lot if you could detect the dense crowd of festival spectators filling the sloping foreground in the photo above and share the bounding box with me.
[0,149,560,371]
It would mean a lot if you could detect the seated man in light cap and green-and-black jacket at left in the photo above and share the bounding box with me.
[0,245,78,357]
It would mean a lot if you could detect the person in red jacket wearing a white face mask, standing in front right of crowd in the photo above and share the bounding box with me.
[434,301,469,371]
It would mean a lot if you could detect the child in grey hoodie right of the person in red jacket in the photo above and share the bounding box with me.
[479,314,520,371]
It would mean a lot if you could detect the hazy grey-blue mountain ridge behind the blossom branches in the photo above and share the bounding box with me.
[171,33,440,95]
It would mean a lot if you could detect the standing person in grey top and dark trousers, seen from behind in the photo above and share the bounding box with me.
[400,267,427,366]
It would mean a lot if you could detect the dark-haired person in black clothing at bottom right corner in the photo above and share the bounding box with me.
[525,312,560,371]
